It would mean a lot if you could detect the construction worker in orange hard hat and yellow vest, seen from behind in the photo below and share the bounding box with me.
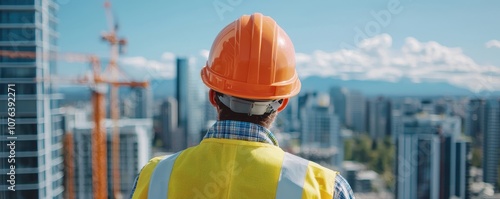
[132,13,354,199]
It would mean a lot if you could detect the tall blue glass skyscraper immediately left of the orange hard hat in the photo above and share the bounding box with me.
[176,58,205,148]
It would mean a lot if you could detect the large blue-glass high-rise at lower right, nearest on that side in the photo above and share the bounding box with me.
[395,113,469,199]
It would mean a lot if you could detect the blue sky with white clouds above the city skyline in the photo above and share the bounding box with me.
[58,0,500,91]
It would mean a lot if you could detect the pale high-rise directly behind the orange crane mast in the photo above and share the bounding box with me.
[65,109,153,198]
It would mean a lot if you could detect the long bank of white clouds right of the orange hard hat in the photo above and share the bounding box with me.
[296,34,500,92]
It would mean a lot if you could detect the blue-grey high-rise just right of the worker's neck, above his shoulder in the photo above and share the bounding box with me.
[300,93,344,169]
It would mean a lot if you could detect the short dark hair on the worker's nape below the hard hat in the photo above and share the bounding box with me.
[215,91,278,128]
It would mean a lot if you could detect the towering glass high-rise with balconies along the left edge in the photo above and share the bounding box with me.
[0,0,64,198]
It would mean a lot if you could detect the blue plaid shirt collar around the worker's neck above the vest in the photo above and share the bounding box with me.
[203,120,278,146]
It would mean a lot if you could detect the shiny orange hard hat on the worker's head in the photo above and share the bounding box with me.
[201,13,301,99]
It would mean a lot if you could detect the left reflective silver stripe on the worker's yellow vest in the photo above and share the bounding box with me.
[148,152,181,198]
